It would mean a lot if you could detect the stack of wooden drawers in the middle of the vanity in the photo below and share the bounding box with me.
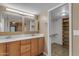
[21,39,30,56]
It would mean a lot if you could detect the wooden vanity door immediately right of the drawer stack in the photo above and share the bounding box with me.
[31,39,38,56]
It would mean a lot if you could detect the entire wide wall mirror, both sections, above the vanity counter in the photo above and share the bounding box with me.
[0,12,38,32]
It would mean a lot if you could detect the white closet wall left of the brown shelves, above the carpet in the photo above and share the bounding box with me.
[50,18,62,45]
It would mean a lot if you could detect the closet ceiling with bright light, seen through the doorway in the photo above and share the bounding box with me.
[51,4,69,20]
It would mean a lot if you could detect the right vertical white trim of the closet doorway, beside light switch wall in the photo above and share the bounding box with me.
[69,3,72,56]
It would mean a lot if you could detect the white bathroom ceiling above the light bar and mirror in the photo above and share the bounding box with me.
[2,3,61,14]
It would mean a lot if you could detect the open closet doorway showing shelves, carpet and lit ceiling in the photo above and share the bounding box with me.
[49,4,69,56]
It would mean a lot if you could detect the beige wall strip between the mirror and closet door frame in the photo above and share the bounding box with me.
[38,11,48,54]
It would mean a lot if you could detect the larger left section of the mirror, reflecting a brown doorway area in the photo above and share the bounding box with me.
[0,12,22,32]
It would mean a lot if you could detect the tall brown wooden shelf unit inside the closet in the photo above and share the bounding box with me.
[62,18,69,48]
